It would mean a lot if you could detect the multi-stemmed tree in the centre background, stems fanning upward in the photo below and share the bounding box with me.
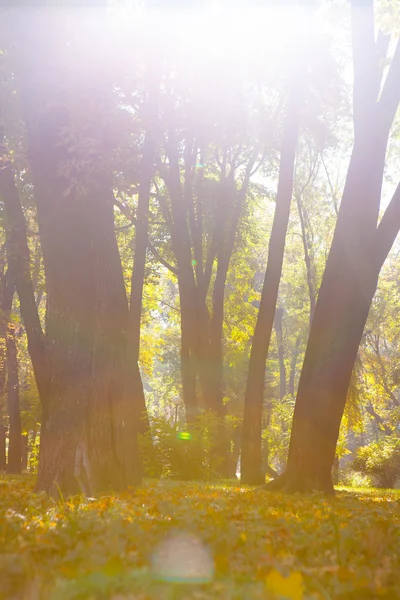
[153,54,272,434]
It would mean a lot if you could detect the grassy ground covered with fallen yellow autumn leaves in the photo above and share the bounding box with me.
[0,476,400,600]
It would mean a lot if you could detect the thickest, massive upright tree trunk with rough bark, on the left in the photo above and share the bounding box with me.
[10,12,141,495]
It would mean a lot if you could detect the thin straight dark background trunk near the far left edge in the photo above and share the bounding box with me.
[6,325,22,473]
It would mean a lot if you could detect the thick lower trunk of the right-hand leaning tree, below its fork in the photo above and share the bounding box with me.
[285,232,378,493]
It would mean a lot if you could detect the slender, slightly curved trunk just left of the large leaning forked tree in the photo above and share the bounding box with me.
[241,84,300,485]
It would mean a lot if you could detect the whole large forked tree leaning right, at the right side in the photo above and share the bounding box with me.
[270,0,400,493]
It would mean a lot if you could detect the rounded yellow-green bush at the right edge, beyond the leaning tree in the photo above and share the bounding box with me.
[352,436,400,488]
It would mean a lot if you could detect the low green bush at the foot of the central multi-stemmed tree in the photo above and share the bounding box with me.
[139,412,220,481]
